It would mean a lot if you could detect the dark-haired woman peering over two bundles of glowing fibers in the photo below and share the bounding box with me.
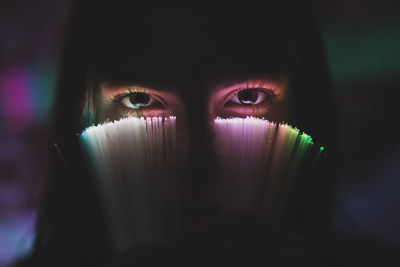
[18,1,337,266]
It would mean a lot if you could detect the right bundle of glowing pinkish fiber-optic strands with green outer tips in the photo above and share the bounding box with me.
[215,117,324,218]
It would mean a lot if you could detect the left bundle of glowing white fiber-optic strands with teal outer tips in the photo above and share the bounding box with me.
[81,117,177,252]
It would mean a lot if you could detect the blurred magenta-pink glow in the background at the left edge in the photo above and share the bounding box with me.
[0,66,33,132]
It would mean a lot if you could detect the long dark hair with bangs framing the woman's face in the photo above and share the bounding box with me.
[18,1,337,266]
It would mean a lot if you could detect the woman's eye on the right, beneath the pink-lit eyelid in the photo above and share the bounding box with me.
[228,88,274,106]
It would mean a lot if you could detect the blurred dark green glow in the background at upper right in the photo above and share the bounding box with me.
[323,21,400,86]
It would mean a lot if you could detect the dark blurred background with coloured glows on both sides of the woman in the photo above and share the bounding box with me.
[0,0,400,267]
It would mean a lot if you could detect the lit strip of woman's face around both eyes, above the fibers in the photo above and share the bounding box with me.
[98,75,290,122]
